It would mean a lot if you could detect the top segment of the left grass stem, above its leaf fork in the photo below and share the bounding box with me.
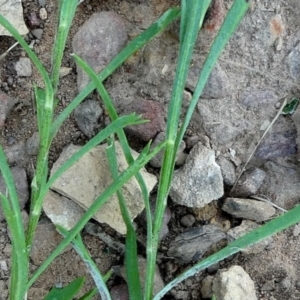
[51,0,77,94]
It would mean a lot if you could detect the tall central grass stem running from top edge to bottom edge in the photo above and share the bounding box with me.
[145,0,210,300]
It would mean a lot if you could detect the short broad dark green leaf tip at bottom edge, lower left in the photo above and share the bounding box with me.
[44,277,85,300]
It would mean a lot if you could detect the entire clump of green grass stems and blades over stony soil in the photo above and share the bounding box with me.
[0,0,300,300]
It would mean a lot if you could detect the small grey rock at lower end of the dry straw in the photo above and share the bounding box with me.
[231,168,266,197]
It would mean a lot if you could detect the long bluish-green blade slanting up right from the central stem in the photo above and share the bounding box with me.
[175,0,250,149]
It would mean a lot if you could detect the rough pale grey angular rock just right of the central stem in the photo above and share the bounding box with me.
[170,143,224,208]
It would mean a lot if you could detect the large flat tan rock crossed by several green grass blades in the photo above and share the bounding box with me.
[51,141,157,234]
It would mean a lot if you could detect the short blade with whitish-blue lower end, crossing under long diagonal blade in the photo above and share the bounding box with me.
[56,226,111,300]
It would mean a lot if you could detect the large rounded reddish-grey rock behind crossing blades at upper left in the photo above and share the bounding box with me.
[72,11,127,92]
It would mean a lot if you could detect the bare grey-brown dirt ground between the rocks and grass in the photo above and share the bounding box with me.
[0,0,300,300]
